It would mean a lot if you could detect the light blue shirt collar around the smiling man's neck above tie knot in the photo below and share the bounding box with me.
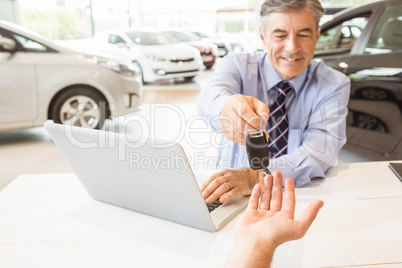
[263,54,310,92]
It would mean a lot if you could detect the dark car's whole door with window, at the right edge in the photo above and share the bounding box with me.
[345,4,402,157]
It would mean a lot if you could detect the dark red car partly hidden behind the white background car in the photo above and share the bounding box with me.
[164,30,218,69]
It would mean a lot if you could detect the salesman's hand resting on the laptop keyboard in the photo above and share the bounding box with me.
[201,168,259,203]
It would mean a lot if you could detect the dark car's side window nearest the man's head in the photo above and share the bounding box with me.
[315,14,370,55]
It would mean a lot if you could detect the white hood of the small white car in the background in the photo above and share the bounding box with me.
[133,43,198,60]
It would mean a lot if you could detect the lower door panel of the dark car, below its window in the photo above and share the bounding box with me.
[347,51,402,156]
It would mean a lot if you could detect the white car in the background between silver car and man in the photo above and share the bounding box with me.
[94,30,203,82]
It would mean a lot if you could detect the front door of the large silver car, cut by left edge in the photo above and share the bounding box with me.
[0,28,38,129]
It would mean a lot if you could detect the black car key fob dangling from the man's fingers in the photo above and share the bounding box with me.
[246,118,271,190]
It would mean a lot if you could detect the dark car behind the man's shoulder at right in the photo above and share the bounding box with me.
[315,0,402,160]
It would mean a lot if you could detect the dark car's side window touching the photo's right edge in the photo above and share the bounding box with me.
[365,5,402,54]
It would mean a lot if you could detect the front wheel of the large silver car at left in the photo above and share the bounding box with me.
[51,87,109,129]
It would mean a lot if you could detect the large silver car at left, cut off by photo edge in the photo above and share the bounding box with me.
[0,21,142,131]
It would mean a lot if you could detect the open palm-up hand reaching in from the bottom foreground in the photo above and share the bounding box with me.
[228,171,324,267]
